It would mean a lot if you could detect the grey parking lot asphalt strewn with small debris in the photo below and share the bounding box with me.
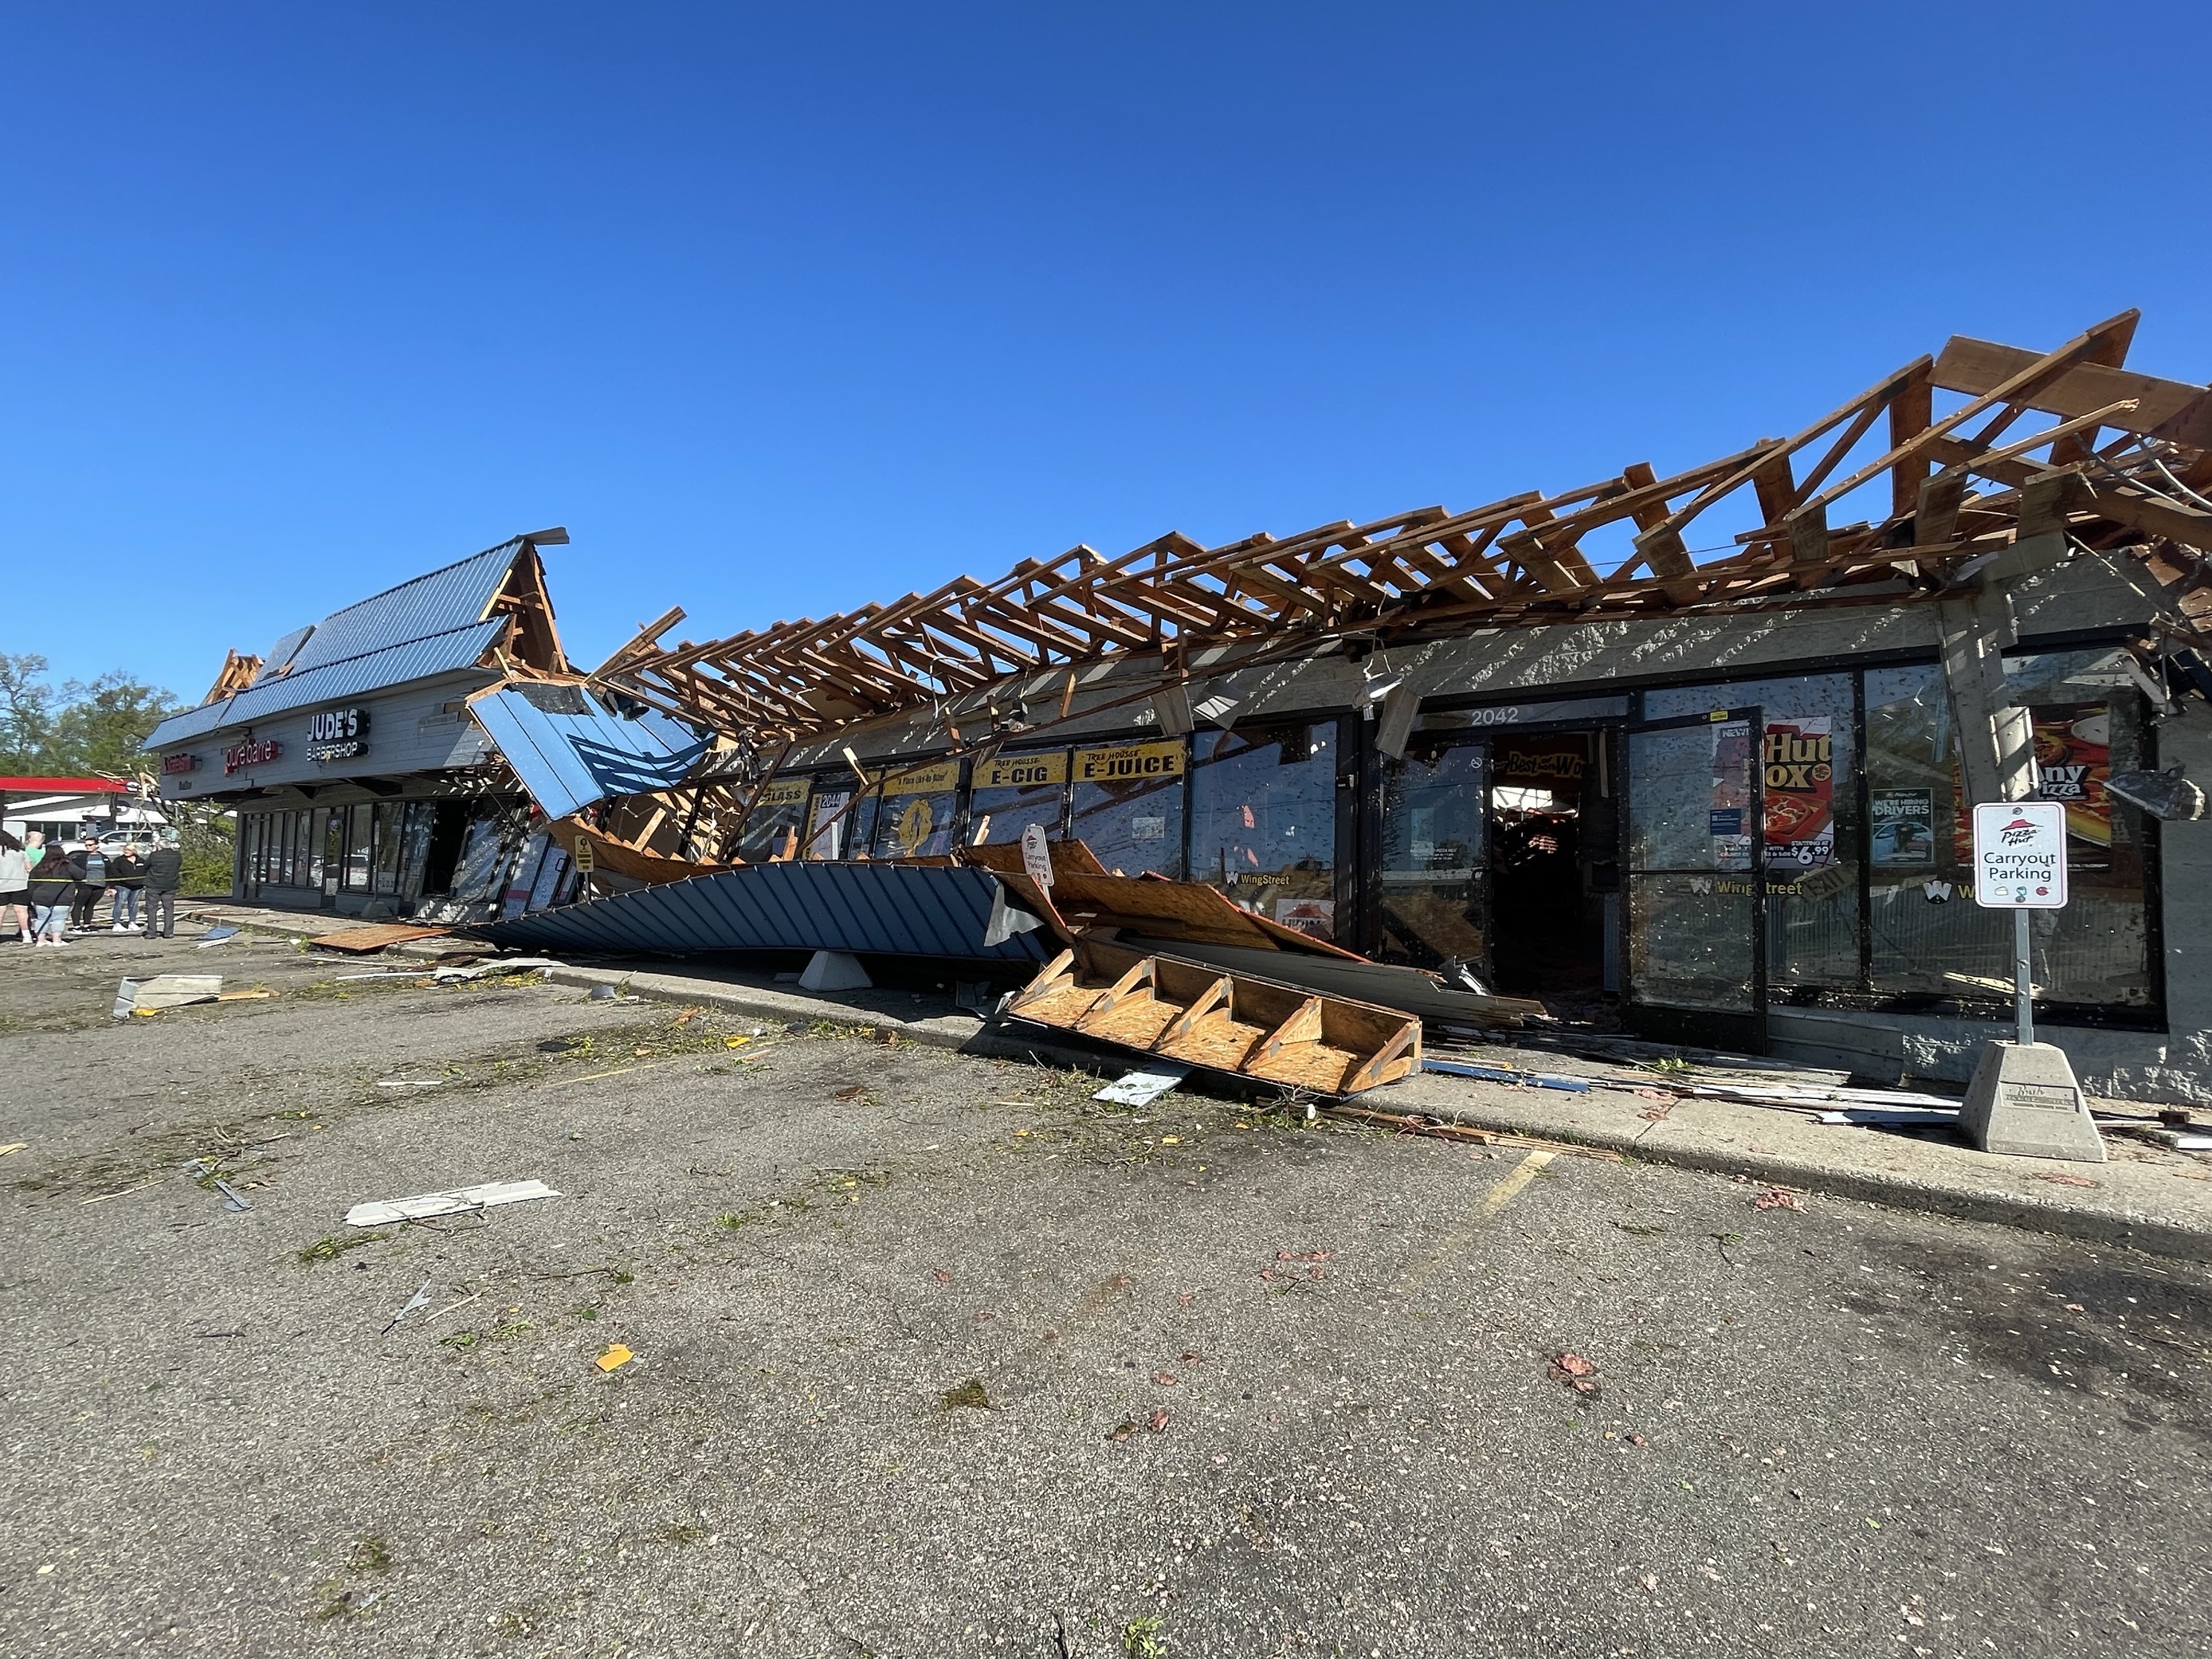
[0,938,2212,1659]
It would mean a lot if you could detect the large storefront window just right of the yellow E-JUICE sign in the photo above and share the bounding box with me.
[1190,719,1336,938]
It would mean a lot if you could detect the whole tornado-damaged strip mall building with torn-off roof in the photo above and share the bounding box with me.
[157,325,2212,1101]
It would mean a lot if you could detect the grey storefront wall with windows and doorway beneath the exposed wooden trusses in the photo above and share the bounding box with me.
[741,555,2212,1100]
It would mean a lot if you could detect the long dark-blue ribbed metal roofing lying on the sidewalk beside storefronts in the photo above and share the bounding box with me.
[462,863,1060,964]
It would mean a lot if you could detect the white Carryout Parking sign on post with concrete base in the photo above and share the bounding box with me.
[1958,801,2104,1163]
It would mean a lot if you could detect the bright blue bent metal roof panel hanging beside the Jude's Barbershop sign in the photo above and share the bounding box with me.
[469,686,712,818]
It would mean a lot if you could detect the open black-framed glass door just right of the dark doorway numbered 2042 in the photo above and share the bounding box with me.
[1624,708,1767,1053]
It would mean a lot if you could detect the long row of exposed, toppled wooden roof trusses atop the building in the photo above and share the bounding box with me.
[590,310,2212,743]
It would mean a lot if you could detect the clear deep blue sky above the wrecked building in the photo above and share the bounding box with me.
[0,5,2212,701]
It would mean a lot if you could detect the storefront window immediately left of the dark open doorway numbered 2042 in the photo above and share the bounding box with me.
[1380,736,1488,967]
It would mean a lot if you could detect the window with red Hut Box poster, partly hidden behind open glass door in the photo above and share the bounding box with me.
[1644,675,1865,989]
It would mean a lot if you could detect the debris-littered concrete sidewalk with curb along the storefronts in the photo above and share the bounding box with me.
[194,904,2212,1261]
